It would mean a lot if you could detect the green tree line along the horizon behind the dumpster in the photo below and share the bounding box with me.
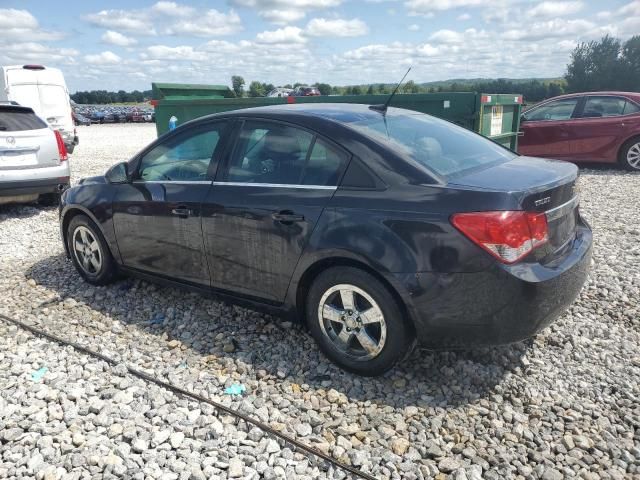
[71,35,640,104]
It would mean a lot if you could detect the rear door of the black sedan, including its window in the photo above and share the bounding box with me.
[202,120,349,303]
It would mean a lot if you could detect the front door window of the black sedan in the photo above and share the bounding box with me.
[138,123,224,181]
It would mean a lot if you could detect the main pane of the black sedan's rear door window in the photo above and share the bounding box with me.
[225,121,313,185]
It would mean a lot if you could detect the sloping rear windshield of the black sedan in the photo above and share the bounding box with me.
[345,109,516,177]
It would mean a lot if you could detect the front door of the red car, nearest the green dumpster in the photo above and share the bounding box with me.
[518,97,582,160]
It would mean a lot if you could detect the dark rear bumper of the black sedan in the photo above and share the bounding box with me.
[395,218,593,349]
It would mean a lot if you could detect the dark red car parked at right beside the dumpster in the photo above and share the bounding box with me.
[518,92,640,170]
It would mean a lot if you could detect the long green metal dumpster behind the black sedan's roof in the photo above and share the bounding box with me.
[152,83,522,151]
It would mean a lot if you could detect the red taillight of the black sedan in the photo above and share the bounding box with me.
[451,211,549,263]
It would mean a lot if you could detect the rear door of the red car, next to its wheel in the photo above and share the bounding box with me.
[571,95,640,162]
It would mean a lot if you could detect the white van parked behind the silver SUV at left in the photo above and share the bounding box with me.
[0,65,78,153]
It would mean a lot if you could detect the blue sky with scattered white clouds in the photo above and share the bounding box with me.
[0,0,640,92]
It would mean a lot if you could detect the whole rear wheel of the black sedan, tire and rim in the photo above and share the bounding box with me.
[306,267,414,377]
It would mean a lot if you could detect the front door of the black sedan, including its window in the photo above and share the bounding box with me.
[113,122,226,286]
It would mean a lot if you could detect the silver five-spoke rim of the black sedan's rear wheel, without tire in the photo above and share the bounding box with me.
[318,284,387,361]
